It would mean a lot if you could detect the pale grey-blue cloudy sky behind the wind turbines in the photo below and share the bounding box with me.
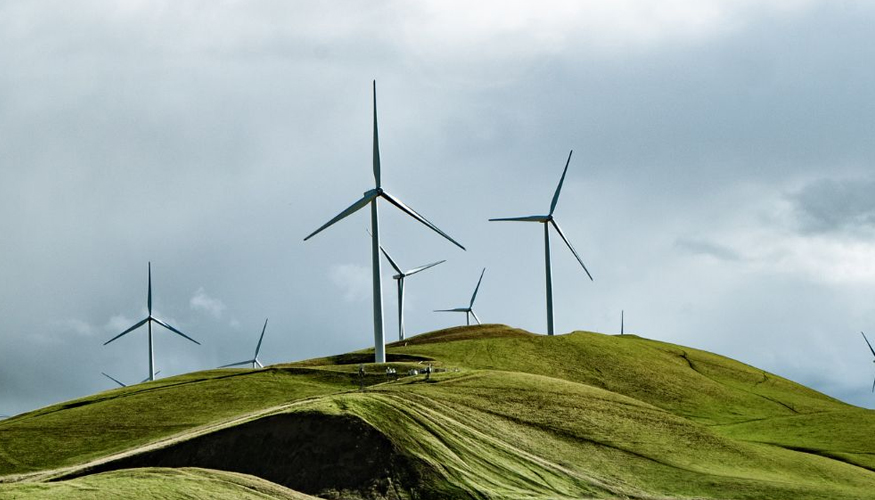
[0,0,875,415]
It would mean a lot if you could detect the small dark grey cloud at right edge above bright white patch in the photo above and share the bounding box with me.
[788,179,875,236]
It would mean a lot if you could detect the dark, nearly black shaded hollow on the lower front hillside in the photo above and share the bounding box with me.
[61,413,468,500]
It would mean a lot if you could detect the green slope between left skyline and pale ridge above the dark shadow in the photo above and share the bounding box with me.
[0,368,362,476]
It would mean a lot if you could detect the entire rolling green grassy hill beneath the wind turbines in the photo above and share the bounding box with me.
[0,325,875,499]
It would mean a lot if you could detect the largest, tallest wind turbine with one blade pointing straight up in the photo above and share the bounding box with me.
[304,80,465,363]
